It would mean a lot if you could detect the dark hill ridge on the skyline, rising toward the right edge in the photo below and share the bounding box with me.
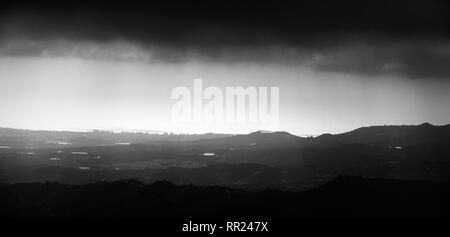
[188,123,450,148]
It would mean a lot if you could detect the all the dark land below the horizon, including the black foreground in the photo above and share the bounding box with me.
[0,124,450,216]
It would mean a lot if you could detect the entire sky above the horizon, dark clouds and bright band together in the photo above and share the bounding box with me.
[0,1,450,135]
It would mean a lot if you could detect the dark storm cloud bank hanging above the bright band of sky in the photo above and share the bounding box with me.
[0,1,450,78]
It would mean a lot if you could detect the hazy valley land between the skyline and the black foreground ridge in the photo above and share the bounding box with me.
[0,123,450,218]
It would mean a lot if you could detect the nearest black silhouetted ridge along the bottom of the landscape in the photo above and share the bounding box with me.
[0,176,450,217]
